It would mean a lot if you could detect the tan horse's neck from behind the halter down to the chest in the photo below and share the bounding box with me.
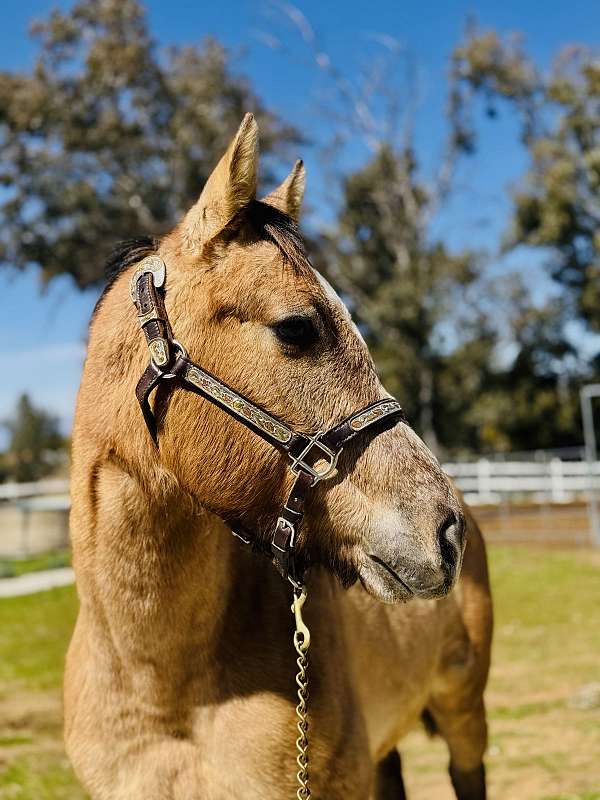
[71,278,298,679]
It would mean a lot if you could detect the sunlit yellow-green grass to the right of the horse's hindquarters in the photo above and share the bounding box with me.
[478,547,600,800]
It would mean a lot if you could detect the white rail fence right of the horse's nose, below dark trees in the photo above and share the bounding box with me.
[443,458,600,505]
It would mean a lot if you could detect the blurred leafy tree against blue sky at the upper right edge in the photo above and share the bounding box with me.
[453,28,600,332]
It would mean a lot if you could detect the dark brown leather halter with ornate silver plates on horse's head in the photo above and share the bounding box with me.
[130,256,405,586]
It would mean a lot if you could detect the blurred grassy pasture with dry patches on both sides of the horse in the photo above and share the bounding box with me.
[0,545,600,800]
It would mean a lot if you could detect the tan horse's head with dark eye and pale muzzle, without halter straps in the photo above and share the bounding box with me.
[154,115,464,601]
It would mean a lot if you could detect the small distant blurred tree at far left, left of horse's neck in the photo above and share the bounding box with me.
[4,394,64,482]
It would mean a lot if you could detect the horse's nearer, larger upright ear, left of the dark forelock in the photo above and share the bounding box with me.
[181,114,258,246]
